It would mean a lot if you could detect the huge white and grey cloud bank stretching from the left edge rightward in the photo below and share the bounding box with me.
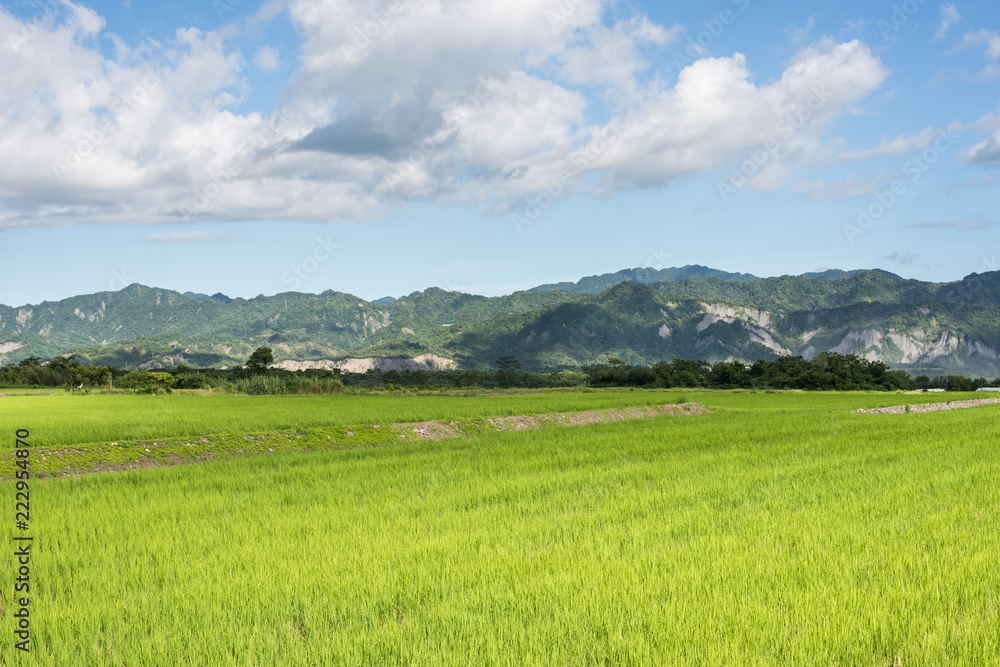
[0,0,888,228]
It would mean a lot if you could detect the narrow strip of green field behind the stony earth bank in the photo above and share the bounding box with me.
[0,390,983,447]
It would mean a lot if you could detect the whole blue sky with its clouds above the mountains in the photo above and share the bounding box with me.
[0,0,1000,306]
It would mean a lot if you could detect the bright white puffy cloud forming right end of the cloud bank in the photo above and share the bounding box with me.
[599,40,888,189]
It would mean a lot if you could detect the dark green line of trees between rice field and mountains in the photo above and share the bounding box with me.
[0,348,1000,394]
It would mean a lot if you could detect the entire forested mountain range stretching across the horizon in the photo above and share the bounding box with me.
[0,266,1000,377]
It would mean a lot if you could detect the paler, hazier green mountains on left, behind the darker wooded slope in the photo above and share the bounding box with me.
[0,284,582,367]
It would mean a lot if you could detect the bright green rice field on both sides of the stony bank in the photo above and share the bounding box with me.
[0,391,1000,667]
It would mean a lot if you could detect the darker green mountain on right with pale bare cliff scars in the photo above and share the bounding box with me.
[352,272,1000,377]
